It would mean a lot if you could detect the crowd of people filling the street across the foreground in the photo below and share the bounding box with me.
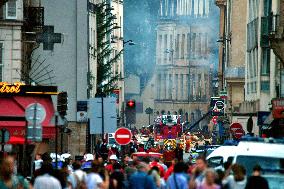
[0,153,269,189]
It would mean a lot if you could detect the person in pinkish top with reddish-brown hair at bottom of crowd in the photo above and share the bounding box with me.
[197,168,221,189]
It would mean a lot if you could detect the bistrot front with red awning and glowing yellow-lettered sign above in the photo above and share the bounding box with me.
[0,82,57,143]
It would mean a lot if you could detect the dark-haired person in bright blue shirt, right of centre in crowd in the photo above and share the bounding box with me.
[167,162,189,189]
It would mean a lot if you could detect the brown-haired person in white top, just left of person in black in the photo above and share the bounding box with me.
[222,164,247,189]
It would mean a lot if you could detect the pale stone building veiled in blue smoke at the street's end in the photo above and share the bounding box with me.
[154,0,218,123]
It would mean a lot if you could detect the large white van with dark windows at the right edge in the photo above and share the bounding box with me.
[233,138,284,175]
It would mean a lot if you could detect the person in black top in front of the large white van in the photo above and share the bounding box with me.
[245,165,269,189]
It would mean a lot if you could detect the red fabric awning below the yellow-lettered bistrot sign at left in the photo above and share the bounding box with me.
[0,96,55,138]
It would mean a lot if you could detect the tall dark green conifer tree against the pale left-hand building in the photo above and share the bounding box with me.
[95,2,123,95]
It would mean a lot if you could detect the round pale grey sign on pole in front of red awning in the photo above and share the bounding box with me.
[25,103,46,124]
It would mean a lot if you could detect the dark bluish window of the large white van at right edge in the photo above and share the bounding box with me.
[236,156,284,175]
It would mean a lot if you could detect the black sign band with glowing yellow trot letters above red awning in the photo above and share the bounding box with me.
[0,82,58,96]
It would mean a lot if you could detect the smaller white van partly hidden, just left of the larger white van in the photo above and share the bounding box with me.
[206,146,237,169]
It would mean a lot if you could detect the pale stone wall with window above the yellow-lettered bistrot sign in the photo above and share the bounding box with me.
[0,0,24,83]
